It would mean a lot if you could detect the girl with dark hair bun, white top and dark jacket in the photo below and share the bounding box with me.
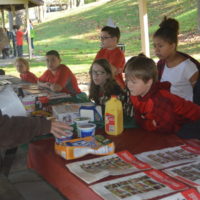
[153,17,199,101]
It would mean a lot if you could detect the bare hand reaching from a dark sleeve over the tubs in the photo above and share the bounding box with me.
[50,121,73,138]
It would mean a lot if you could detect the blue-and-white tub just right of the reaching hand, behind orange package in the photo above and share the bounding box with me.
[77,123,96,137]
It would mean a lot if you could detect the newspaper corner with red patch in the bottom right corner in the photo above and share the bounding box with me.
[160,188,200,200]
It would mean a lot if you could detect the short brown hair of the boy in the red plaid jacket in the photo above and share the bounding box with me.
[125,54,158,83]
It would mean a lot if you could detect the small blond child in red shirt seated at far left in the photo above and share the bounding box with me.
[14,58,38,83]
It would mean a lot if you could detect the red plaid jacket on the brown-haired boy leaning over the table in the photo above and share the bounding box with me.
[131,82,200,133]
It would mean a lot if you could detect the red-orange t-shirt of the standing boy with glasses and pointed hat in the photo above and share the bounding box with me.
[95,47,125,88]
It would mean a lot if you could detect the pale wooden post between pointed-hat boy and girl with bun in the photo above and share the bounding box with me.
[138,0,150,57]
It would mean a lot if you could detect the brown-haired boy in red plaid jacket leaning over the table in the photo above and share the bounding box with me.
[125,55,200,139]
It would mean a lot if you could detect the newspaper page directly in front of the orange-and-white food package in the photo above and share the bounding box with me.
[66,151,151,184]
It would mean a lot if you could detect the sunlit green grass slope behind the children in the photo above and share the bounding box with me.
[2,0,200,75]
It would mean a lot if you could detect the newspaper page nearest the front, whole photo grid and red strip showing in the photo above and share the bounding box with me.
[90,169,187,200]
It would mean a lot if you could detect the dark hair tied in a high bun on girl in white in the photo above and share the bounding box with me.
[153,17,179,44]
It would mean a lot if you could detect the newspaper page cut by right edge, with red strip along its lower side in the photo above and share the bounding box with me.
[164,160,200,191]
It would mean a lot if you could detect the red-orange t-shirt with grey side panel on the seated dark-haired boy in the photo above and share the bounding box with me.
[39,64,81,95]
